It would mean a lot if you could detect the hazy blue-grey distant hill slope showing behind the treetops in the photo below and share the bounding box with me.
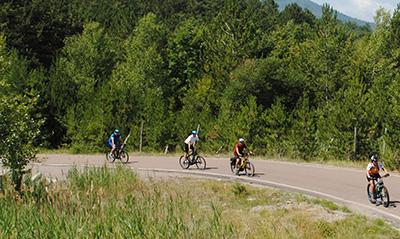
[275,0,375,28]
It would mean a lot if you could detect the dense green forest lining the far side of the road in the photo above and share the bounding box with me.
[0,0,400,168]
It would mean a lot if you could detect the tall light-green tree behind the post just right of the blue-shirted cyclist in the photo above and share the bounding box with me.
[110,13,170,150]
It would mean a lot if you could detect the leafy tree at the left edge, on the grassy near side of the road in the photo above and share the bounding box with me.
[0,37,43,190]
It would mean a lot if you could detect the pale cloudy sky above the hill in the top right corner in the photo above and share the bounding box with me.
[311,0,400,22]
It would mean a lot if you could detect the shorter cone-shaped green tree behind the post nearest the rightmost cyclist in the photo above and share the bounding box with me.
[317,75,370,160]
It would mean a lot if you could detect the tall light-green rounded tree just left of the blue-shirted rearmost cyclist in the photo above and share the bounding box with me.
[50,23,116,152]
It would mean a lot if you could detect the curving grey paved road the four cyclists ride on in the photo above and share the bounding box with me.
[33,154,400,227]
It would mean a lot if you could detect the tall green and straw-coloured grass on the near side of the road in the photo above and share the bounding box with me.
[0,166,400,239]
